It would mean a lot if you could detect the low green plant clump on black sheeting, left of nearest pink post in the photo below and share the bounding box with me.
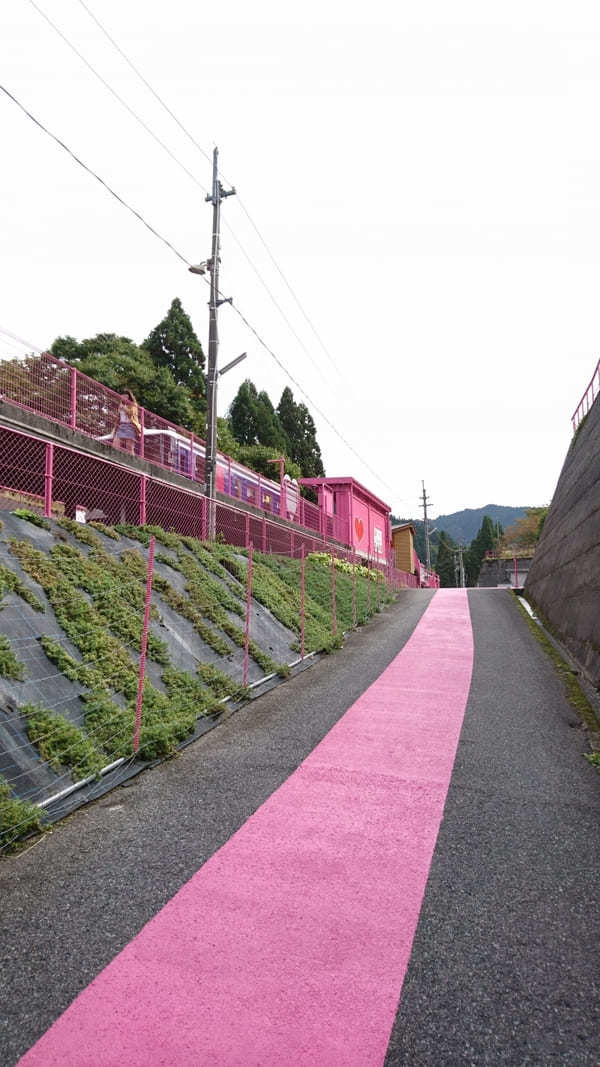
[21,704,105,780]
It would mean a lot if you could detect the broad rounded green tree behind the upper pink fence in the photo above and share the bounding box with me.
[51,334,204,433]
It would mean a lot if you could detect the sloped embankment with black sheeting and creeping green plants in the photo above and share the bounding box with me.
[0,513,382,847]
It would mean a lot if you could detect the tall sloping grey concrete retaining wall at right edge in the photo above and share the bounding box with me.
[525,399,600,688]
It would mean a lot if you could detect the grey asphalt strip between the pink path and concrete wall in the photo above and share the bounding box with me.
[385,590,600,1067]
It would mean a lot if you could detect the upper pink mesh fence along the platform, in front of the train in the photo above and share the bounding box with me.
[0,352,350,543]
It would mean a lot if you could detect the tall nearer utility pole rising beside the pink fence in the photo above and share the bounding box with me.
[190,147,235,541]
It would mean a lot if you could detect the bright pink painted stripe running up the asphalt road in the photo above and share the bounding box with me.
[20,590,473,1067]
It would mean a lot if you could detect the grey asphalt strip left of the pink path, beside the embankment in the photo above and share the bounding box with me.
[0,590,432,1067]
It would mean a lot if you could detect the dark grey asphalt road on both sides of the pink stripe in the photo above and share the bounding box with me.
[0,590,600,1067]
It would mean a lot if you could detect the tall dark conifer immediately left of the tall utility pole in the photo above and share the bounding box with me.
[142,297,206,416]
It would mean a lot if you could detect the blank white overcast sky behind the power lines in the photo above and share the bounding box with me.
[0,0,600,516]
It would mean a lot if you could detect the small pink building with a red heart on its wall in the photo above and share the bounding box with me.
[300,478,392,563]
